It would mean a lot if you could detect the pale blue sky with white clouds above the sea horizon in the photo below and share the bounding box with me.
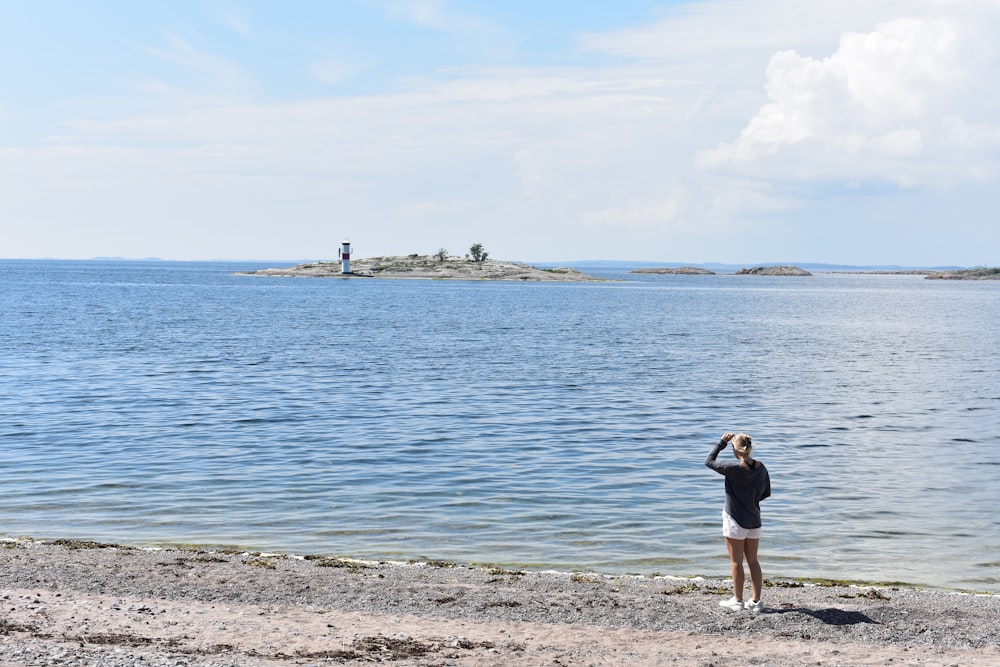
[0,0,1000,266]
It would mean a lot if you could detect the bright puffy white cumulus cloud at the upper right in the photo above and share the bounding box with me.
[699,16,1000,186]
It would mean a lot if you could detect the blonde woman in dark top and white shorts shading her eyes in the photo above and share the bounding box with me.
[705,433,771,612]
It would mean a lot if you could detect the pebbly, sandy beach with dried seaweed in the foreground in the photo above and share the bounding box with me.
[0,540,1000,667]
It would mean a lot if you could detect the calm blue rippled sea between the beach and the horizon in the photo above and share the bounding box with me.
[0,260,1000,591]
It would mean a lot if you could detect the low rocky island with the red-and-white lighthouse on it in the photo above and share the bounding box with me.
[237,255,610,282]
